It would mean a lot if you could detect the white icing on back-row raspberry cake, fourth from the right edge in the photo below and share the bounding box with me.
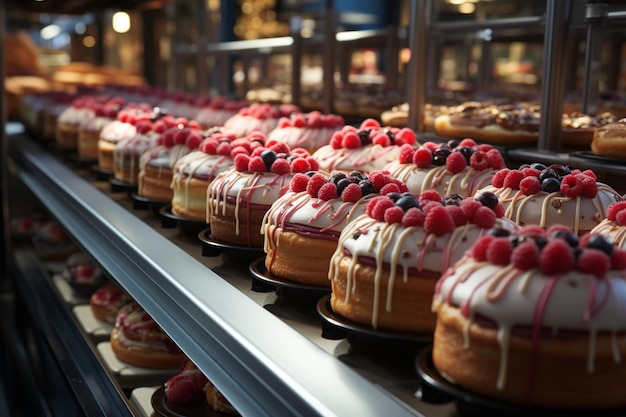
[313,145,400,173]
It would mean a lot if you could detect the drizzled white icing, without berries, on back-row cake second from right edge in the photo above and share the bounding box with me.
[476,182,621,233]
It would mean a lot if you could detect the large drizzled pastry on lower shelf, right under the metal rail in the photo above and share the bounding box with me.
[111,301,184,369]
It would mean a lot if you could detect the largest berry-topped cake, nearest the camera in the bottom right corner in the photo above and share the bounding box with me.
[433,225,626,408]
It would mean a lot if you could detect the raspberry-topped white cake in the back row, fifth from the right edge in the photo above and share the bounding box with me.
[267,111,345,153]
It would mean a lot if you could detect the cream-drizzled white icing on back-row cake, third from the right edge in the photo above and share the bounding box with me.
[384,160,497,197]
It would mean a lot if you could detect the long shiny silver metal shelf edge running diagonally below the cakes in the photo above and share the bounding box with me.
[9,135,444,416]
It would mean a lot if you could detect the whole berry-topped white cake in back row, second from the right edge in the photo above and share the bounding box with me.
[476,163,622,234]
